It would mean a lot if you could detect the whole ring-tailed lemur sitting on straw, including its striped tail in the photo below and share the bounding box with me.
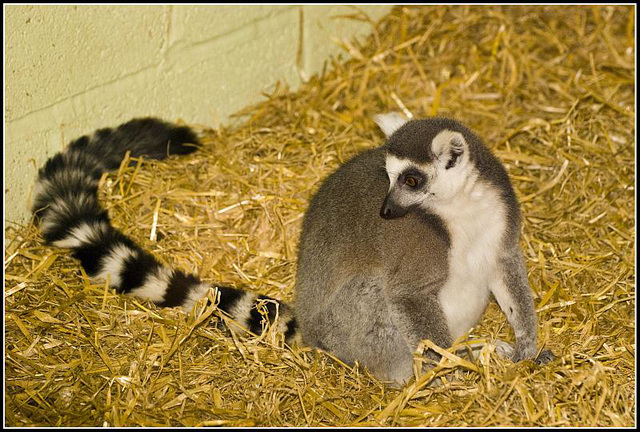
[33,114,551,383]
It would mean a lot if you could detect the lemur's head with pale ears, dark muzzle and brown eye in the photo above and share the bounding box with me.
[376,116,471,219]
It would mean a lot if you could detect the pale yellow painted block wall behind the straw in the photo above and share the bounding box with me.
[4,5,391,222]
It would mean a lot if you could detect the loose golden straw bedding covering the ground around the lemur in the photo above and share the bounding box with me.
[4,6,636,426]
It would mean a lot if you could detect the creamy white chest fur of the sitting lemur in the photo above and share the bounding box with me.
[431,176,506,339]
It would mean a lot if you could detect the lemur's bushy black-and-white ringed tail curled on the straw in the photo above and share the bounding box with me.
[33,118,296,341]
